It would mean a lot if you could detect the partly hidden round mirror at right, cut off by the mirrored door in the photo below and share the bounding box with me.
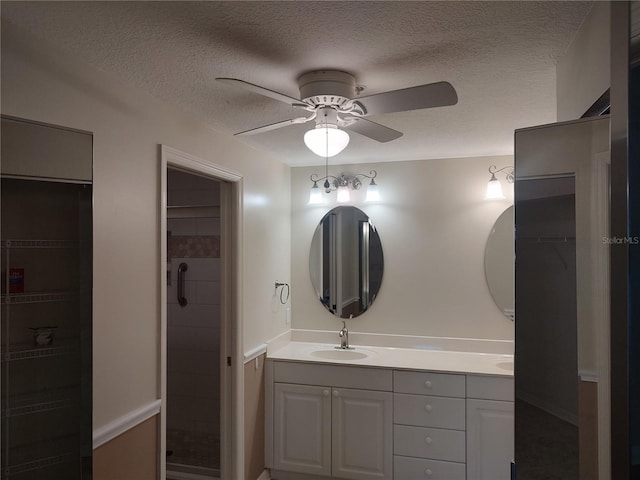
[484,206,515,320]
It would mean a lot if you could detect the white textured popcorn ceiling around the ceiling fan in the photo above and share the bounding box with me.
[1,1,592,166]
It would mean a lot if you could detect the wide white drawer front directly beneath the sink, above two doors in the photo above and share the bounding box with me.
[273,361,393,392]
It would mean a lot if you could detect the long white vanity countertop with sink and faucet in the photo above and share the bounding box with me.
[267,341,513,377]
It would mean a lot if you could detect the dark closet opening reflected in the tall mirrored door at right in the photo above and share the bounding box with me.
[515,175,580,480]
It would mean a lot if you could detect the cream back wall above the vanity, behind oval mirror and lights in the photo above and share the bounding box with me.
[291,156,513,341]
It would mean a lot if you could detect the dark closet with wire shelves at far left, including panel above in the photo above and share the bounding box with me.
[0,117,92,480]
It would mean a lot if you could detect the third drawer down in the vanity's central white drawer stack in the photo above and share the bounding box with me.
[393,425,466,463]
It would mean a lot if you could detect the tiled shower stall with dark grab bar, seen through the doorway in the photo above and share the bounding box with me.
[166,169,222,480]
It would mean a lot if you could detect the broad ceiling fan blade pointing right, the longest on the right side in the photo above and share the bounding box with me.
[354,82,458,115]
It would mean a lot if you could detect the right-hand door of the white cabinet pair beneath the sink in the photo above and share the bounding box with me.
[332,388,393,480]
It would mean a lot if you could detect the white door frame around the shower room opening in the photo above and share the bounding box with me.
[158,145,244,480]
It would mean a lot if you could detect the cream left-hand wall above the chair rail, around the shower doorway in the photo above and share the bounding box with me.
[1,16,291,470]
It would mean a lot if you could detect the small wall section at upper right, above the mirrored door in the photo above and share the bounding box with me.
[556,2,611,122]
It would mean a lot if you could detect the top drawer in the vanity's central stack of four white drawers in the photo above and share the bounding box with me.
[393,370,465,398]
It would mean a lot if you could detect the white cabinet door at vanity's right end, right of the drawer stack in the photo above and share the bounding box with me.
[467,398,514,480]
